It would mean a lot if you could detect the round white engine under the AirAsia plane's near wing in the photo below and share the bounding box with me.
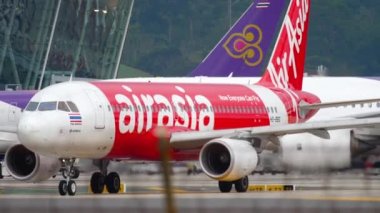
[199,138,258,181]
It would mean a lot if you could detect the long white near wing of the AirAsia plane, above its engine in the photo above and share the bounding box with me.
[170,118,380,149]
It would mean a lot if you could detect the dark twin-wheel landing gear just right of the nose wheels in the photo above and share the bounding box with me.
[91,160,120,194]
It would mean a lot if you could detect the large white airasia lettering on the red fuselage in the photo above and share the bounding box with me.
[115,86,215,134]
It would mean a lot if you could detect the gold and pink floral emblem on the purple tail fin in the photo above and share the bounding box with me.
[223,24,263,67]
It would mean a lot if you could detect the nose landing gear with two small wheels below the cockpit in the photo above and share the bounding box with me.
[58,158,79,196]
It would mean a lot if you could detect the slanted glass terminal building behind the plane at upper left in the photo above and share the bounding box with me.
[0,0,131,90]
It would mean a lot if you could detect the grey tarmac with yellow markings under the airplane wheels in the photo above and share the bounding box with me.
[0,172,380,213]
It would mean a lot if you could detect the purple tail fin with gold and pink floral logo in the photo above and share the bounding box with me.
[189,0,286,77]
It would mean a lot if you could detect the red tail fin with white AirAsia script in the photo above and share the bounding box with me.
[258,0,310,90]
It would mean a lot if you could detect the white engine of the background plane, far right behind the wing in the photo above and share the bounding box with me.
[280,129,373,171]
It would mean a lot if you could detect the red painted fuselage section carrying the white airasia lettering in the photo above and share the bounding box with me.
[92,82,269,160]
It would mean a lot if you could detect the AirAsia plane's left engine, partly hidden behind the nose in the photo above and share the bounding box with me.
[5,144,61,182]
